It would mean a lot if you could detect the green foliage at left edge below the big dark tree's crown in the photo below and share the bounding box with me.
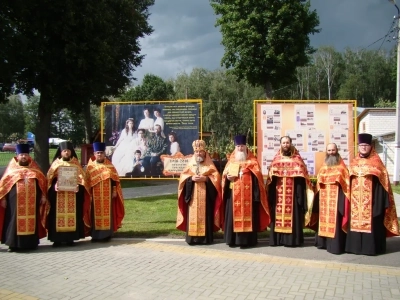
[0,95,25,142]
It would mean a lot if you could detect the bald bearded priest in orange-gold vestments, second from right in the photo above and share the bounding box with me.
[313,143,350,254]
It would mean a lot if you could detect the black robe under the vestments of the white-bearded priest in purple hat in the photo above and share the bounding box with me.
[223,173,260,247]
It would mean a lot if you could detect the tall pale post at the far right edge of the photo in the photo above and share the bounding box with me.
[389,0,400,185]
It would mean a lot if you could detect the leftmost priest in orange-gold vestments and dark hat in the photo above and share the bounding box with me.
[0,144,49,252]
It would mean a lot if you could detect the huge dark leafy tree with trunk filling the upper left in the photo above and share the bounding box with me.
[0,0,154,171]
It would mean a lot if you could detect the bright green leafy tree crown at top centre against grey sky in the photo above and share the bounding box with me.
[210,0,319,99]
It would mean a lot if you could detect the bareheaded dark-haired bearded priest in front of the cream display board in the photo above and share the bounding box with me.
[267,136,314,247]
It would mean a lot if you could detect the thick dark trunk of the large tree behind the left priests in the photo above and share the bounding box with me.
[35,91,52,174]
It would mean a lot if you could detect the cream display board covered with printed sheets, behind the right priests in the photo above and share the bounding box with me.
[255,100,356,176]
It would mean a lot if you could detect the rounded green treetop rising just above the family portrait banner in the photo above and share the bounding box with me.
[121,74,174,101]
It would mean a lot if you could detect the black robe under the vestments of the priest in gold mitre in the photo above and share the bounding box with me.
[182,177,217,245]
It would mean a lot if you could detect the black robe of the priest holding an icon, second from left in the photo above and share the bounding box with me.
[47,178,85,243]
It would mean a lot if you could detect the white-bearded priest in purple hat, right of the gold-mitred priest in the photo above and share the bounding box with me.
[222,135,270,248]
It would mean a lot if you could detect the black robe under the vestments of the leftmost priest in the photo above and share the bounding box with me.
[1,180,42,250]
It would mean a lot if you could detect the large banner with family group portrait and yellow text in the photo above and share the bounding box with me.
[101,100,201,179]
